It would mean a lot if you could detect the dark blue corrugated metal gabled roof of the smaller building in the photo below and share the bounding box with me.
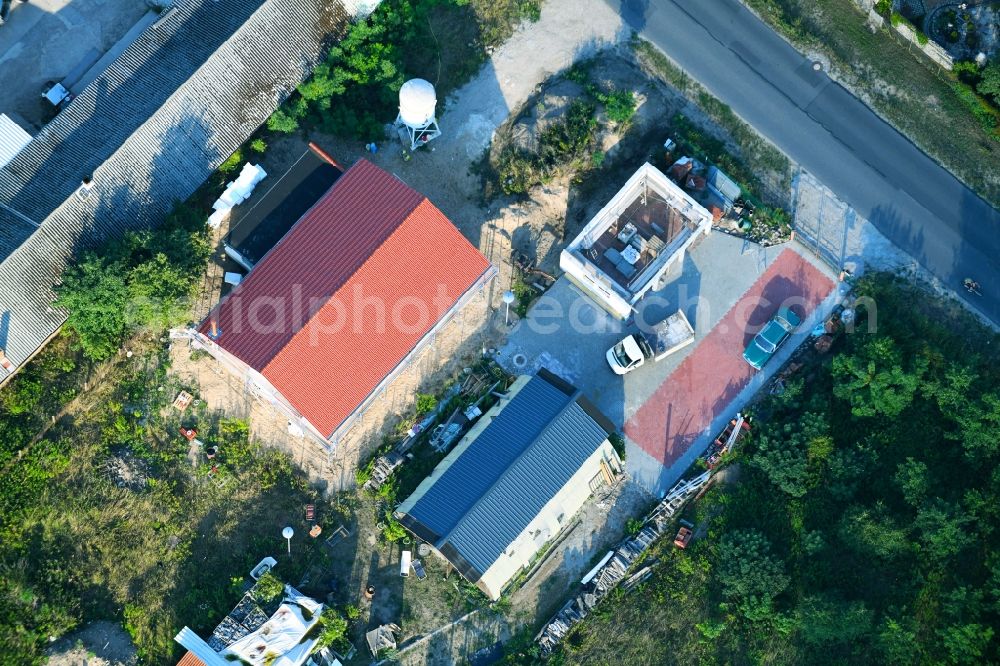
[408,376,608,574]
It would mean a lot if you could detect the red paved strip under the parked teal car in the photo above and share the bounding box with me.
[625,248,834,467]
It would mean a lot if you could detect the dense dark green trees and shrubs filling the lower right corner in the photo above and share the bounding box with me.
[556,274,1000,664]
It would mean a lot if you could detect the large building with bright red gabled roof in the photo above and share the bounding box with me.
[198,160,495,439]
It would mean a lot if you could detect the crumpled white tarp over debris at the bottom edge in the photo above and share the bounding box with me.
[221,586,323,666]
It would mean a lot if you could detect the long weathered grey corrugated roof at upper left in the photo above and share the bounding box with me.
[0,0,360,368]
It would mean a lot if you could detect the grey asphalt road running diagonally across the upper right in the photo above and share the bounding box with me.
[607,0,1000,323]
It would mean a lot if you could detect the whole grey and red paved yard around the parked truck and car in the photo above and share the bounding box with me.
[498,233,835,494]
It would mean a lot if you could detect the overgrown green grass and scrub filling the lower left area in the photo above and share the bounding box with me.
[0,335,324,664]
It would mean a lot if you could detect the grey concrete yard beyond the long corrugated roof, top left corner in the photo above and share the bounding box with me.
[0,0,149,127]
